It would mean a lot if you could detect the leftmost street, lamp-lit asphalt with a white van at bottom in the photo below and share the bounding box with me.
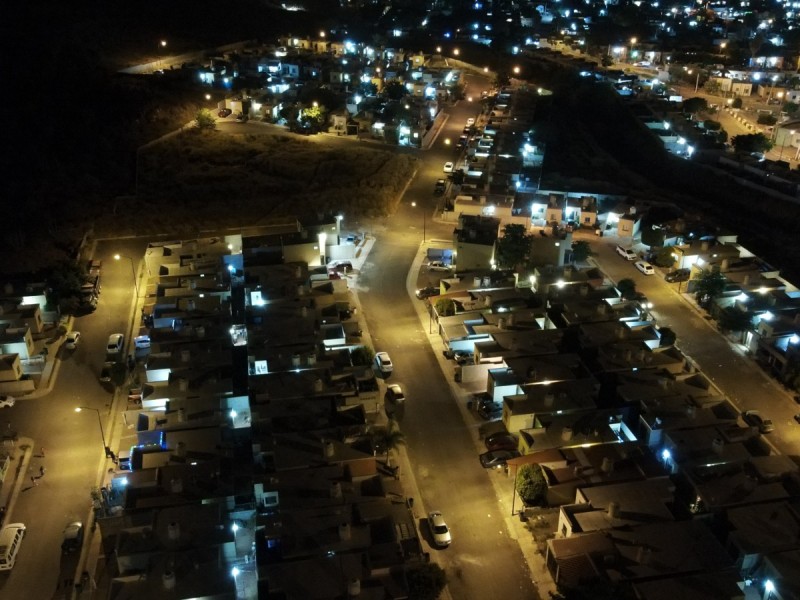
[0,241,144,600]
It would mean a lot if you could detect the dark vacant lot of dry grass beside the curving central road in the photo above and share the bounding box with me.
[95,130,416,235]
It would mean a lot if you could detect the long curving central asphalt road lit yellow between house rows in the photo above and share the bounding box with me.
[358,81,538,599]
